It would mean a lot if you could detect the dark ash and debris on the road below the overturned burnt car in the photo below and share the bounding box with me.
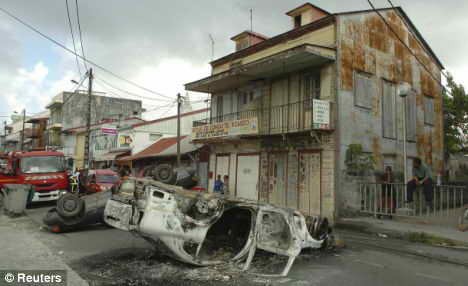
[71,248,336,286]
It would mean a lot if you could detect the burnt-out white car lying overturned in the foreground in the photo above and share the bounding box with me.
[104,179,330,276]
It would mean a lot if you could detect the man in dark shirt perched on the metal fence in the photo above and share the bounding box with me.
[406,158,434,207]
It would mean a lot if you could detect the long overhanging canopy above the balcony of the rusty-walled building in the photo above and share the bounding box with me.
[185,44,335,93]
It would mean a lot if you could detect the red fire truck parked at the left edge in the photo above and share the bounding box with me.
[0,151,68,202]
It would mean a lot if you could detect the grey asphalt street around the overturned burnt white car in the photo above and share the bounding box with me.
[23,204,468,286]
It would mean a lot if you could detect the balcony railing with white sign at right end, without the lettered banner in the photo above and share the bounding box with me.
[193,100,335,139]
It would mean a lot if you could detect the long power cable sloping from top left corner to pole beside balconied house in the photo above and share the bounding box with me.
[0,4,173,99]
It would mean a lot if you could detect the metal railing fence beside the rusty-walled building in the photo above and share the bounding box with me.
[359,183,468,216]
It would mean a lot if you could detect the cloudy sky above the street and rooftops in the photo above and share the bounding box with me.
[0,0,468,120]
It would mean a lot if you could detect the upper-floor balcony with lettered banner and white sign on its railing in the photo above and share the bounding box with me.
[192,100,335,141]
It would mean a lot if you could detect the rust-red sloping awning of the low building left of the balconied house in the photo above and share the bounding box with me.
[118,136,201,161]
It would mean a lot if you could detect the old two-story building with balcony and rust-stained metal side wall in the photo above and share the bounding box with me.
[186,3,443,220]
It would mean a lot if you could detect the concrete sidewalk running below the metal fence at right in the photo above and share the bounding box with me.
[336,217,468,247]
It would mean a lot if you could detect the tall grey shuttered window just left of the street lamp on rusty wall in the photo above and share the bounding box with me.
[382,80,396,139]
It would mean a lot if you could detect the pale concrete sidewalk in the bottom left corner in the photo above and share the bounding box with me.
[0,213,88,286]
